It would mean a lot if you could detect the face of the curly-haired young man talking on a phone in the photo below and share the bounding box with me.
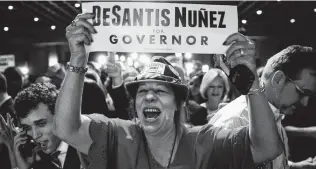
[20,103,60,154]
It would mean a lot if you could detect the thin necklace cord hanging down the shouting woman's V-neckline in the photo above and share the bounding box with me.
[143,129,178,169]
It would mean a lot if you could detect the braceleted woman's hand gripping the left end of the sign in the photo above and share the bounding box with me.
[66,13,97,66]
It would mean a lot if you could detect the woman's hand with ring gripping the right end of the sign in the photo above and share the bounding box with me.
[223,33,257,78]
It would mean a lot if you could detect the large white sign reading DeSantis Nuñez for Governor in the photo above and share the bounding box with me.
[82,2,238,54]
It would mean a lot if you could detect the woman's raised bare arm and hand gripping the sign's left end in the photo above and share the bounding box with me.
[53,13,96,154]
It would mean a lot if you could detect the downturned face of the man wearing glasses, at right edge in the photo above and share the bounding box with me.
[277,69,316,114]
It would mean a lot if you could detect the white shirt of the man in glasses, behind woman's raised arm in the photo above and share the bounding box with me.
[209,96,289,169]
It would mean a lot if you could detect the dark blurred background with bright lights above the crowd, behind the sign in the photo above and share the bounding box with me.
[0,0,316,77]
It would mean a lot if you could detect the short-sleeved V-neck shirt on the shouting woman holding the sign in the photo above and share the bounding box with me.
[79,114,254,169]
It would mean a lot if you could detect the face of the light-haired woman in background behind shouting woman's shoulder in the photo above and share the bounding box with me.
[206,76,224,109]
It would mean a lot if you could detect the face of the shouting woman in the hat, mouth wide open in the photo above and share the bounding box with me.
[135,82,176,134]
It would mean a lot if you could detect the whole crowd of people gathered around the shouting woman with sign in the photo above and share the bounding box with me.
[0,13,316,169]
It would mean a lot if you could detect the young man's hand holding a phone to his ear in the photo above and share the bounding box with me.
[14,131,35,169]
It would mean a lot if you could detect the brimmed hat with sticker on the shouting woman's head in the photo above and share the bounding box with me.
[126,56,189,101]
